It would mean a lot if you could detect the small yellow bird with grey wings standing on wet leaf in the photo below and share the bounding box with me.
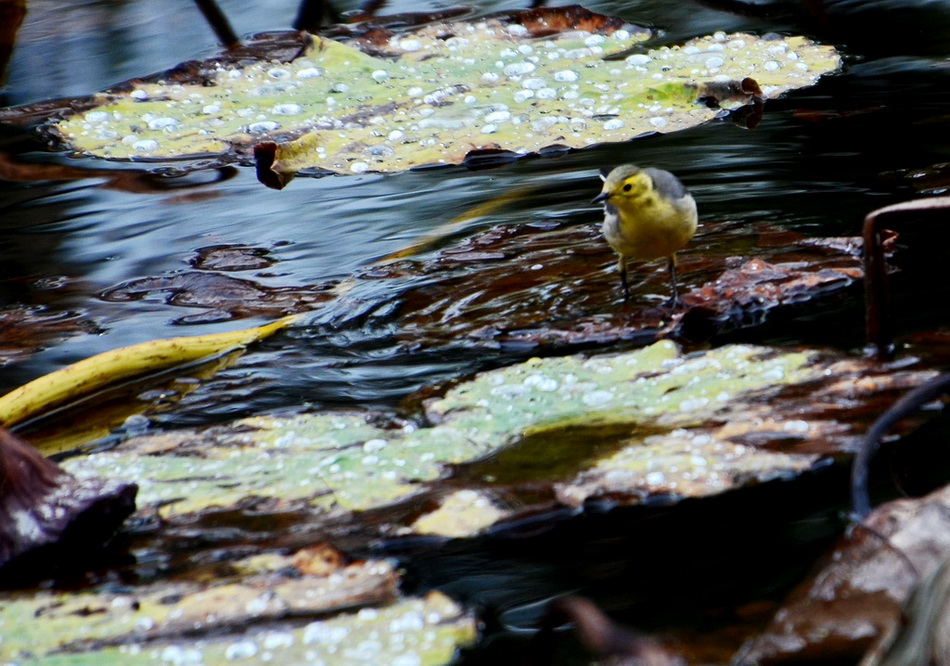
[591,164,697,307]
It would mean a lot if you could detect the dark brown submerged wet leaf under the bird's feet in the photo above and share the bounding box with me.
[93,219,880,355]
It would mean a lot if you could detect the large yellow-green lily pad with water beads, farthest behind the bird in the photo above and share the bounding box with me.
[46,7,840,174]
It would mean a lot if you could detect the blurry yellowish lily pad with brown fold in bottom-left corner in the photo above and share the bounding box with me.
[0,544,475,664]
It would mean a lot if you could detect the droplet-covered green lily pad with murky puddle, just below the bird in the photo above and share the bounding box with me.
[65,341,936,536]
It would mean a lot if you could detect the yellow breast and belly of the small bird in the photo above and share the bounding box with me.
[603,191,697,261]
